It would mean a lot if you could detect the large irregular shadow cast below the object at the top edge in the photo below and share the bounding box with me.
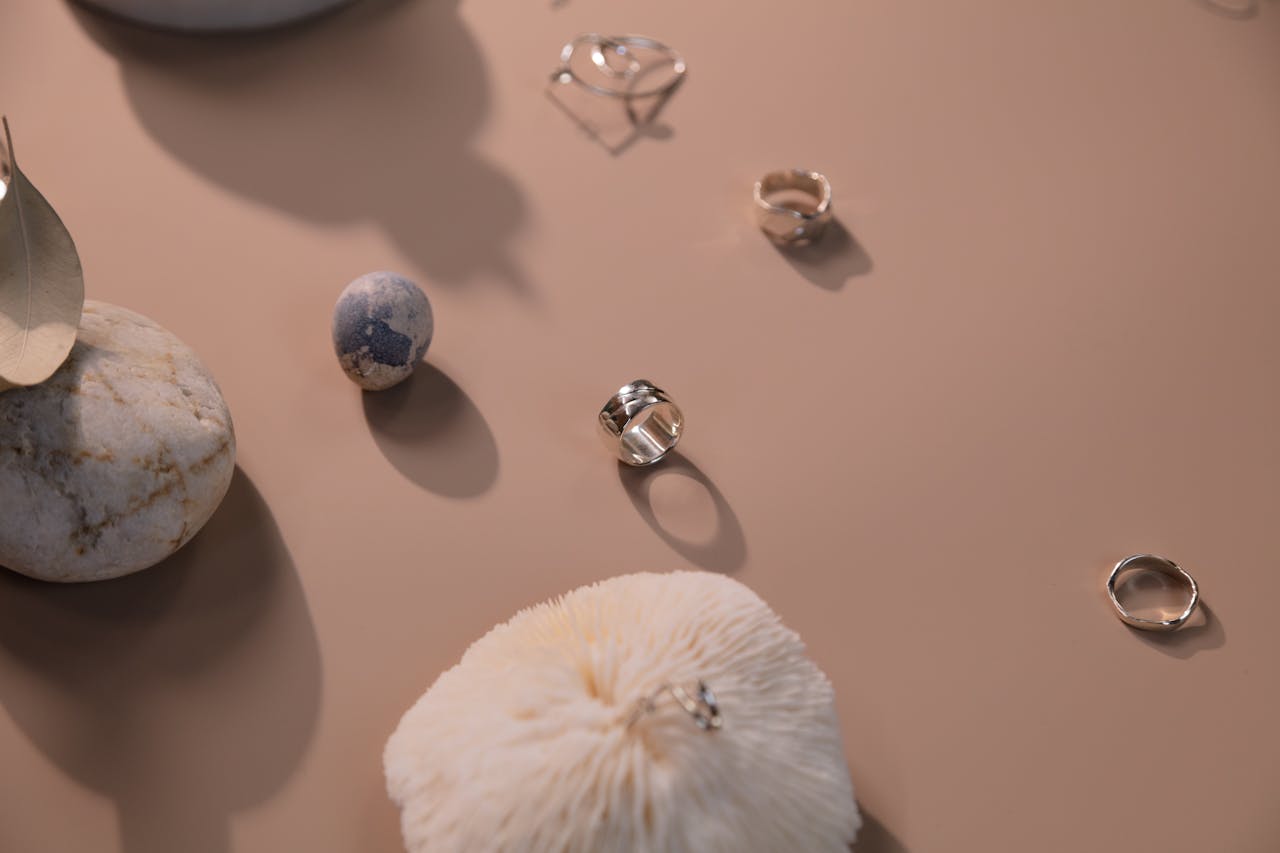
[72,0,532,297]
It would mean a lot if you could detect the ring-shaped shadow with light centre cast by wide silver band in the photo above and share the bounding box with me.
[618,451,746,574]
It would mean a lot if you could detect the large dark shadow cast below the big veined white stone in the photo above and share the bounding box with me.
[0,469,321,853]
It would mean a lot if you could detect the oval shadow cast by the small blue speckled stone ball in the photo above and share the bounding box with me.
[364,364,498,498]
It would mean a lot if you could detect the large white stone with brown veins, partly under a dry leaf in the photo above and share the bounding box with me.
[0,301,236,581]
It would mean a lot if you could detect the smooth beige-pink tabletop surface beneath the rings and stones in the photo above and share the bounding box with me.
[0,0,1280,853]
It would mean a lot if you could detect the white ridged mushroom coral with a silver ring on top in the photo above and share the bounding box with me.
[384,573,860,853]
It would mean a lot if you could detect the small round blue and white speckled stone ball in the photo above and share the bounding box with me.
[333,273,435,391]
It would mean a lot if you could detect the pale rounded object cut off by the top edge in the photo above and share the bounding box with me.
[82,0,349,32]
